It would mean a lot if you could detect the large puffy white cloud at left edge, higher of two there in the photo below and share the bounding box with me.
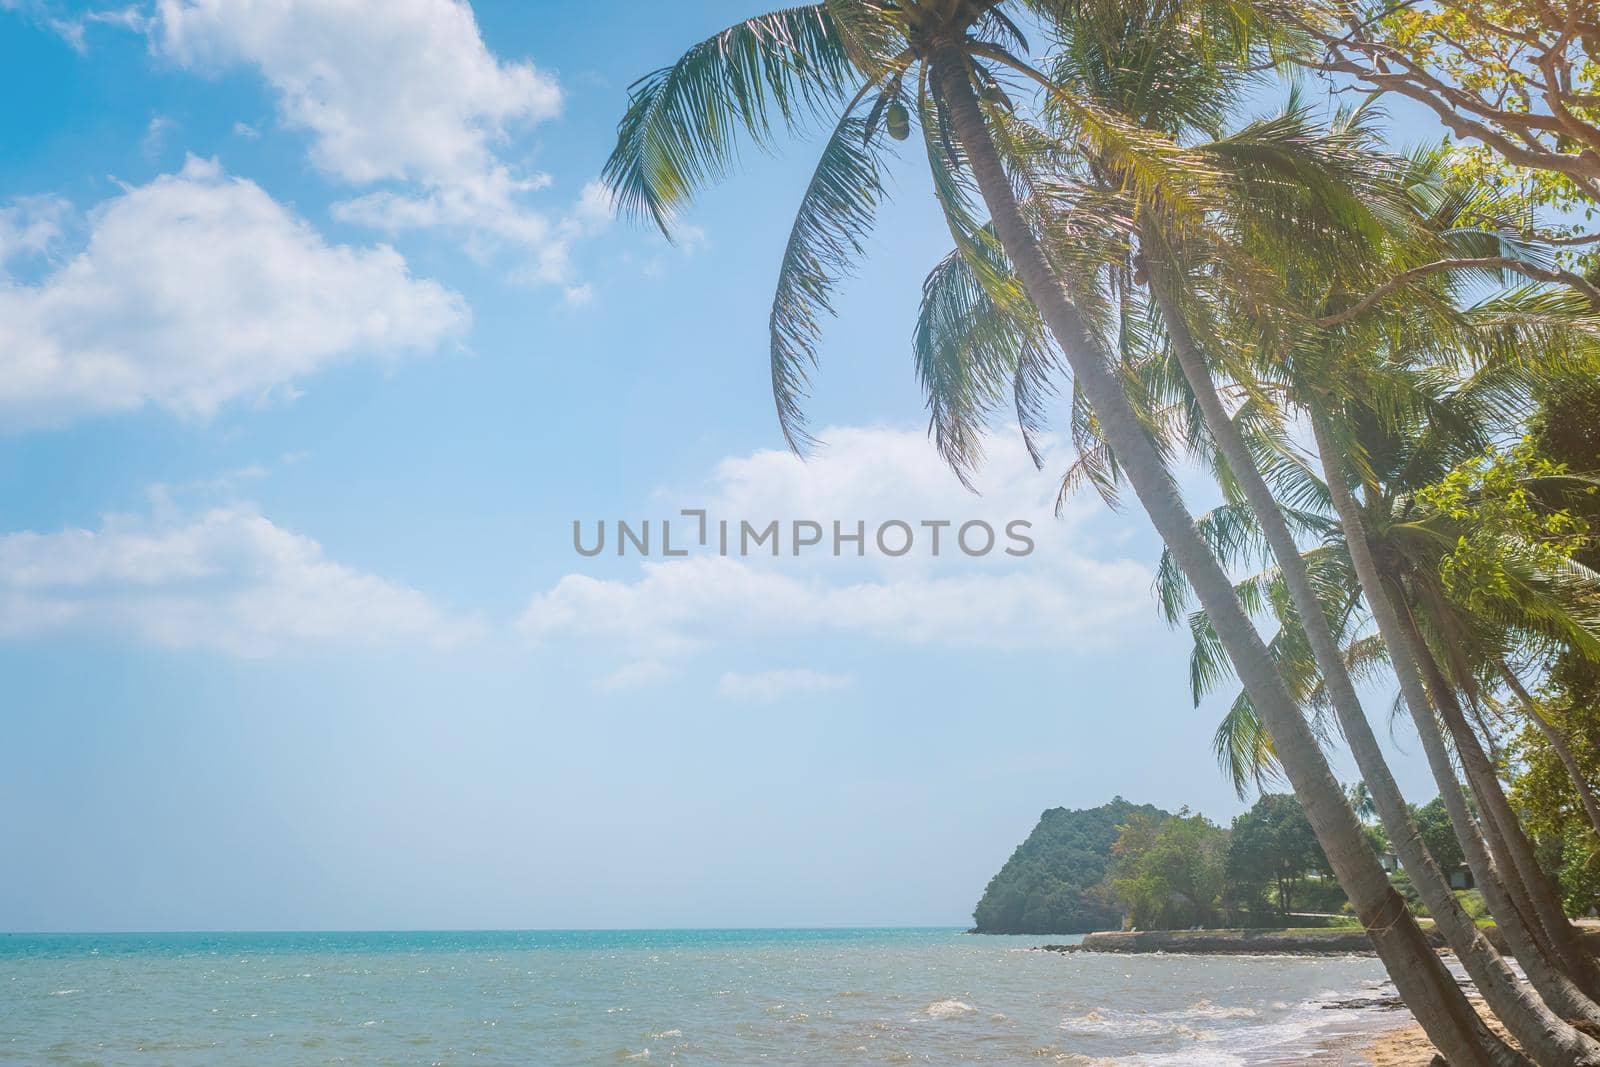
[0,158,469,429]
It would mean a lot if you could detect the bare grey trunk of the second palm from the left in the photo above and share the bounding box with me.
[1144,265,1600,1064]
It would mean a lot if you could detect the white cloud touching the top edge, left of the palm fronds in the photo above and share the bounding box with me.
[150,0,594,283]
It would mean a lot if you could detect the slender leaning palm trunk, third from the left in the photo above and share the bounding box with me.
[1312,411,1600,1036]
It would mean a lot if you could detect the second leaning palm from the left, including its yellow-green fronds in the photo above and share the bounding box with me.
[917,14,1600,1064]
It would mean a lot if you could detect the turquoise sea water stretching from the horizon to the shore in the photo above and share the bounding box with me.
[0,929,1397,1067]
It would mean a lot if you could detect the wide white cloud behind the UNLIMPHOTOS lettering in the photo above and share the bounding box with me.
[520,427,1152,675]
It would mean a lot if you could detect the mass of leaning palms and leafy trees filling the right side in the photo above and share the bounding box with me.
[605,0,1600,1067]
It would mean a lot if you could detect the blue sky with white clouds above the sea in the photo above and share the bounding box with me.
[0,0,1452,929]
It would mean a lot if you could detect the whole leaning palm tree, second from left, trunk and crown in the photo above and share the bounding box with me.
[917,14,1600,1064]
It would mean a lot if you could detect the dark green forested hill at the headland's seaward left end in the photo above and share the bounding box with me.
[973,797,1168,934]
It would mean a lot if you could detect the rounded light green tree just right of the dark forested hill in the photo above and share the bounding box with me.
[1110,808,1229,929]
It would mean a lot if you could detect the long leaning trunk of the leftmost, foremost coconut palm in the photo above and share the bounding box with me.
[930,38,1526,1067]
